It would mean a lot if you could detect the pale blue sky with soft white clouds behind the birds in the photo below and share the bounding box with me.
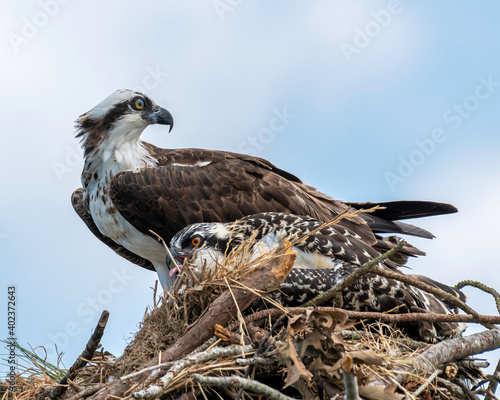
[0,0,500,376]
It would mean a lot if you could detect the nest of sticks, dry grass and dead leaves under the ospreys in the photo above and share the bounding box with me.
[4,231,500,400]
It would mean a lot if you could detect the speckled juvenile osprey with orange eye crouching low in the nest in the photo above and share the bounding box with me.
[170,213,465,342]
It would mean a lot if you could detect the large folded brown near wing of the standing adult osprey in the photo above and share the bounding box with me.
[110,144,376,244]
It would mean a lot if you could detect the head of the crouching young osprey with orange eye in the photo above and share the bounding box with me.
[167,223,237,277]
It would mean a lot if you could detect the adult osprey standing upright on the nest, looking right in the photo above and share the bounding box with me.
[72,90,457,289]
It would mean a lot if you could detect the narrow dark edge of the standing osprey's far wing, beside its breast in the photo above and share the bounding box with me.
[71,188,155,271]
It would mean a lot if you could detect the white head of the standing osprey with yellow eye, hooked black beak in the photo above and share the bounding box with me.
[76,89,174,153]
